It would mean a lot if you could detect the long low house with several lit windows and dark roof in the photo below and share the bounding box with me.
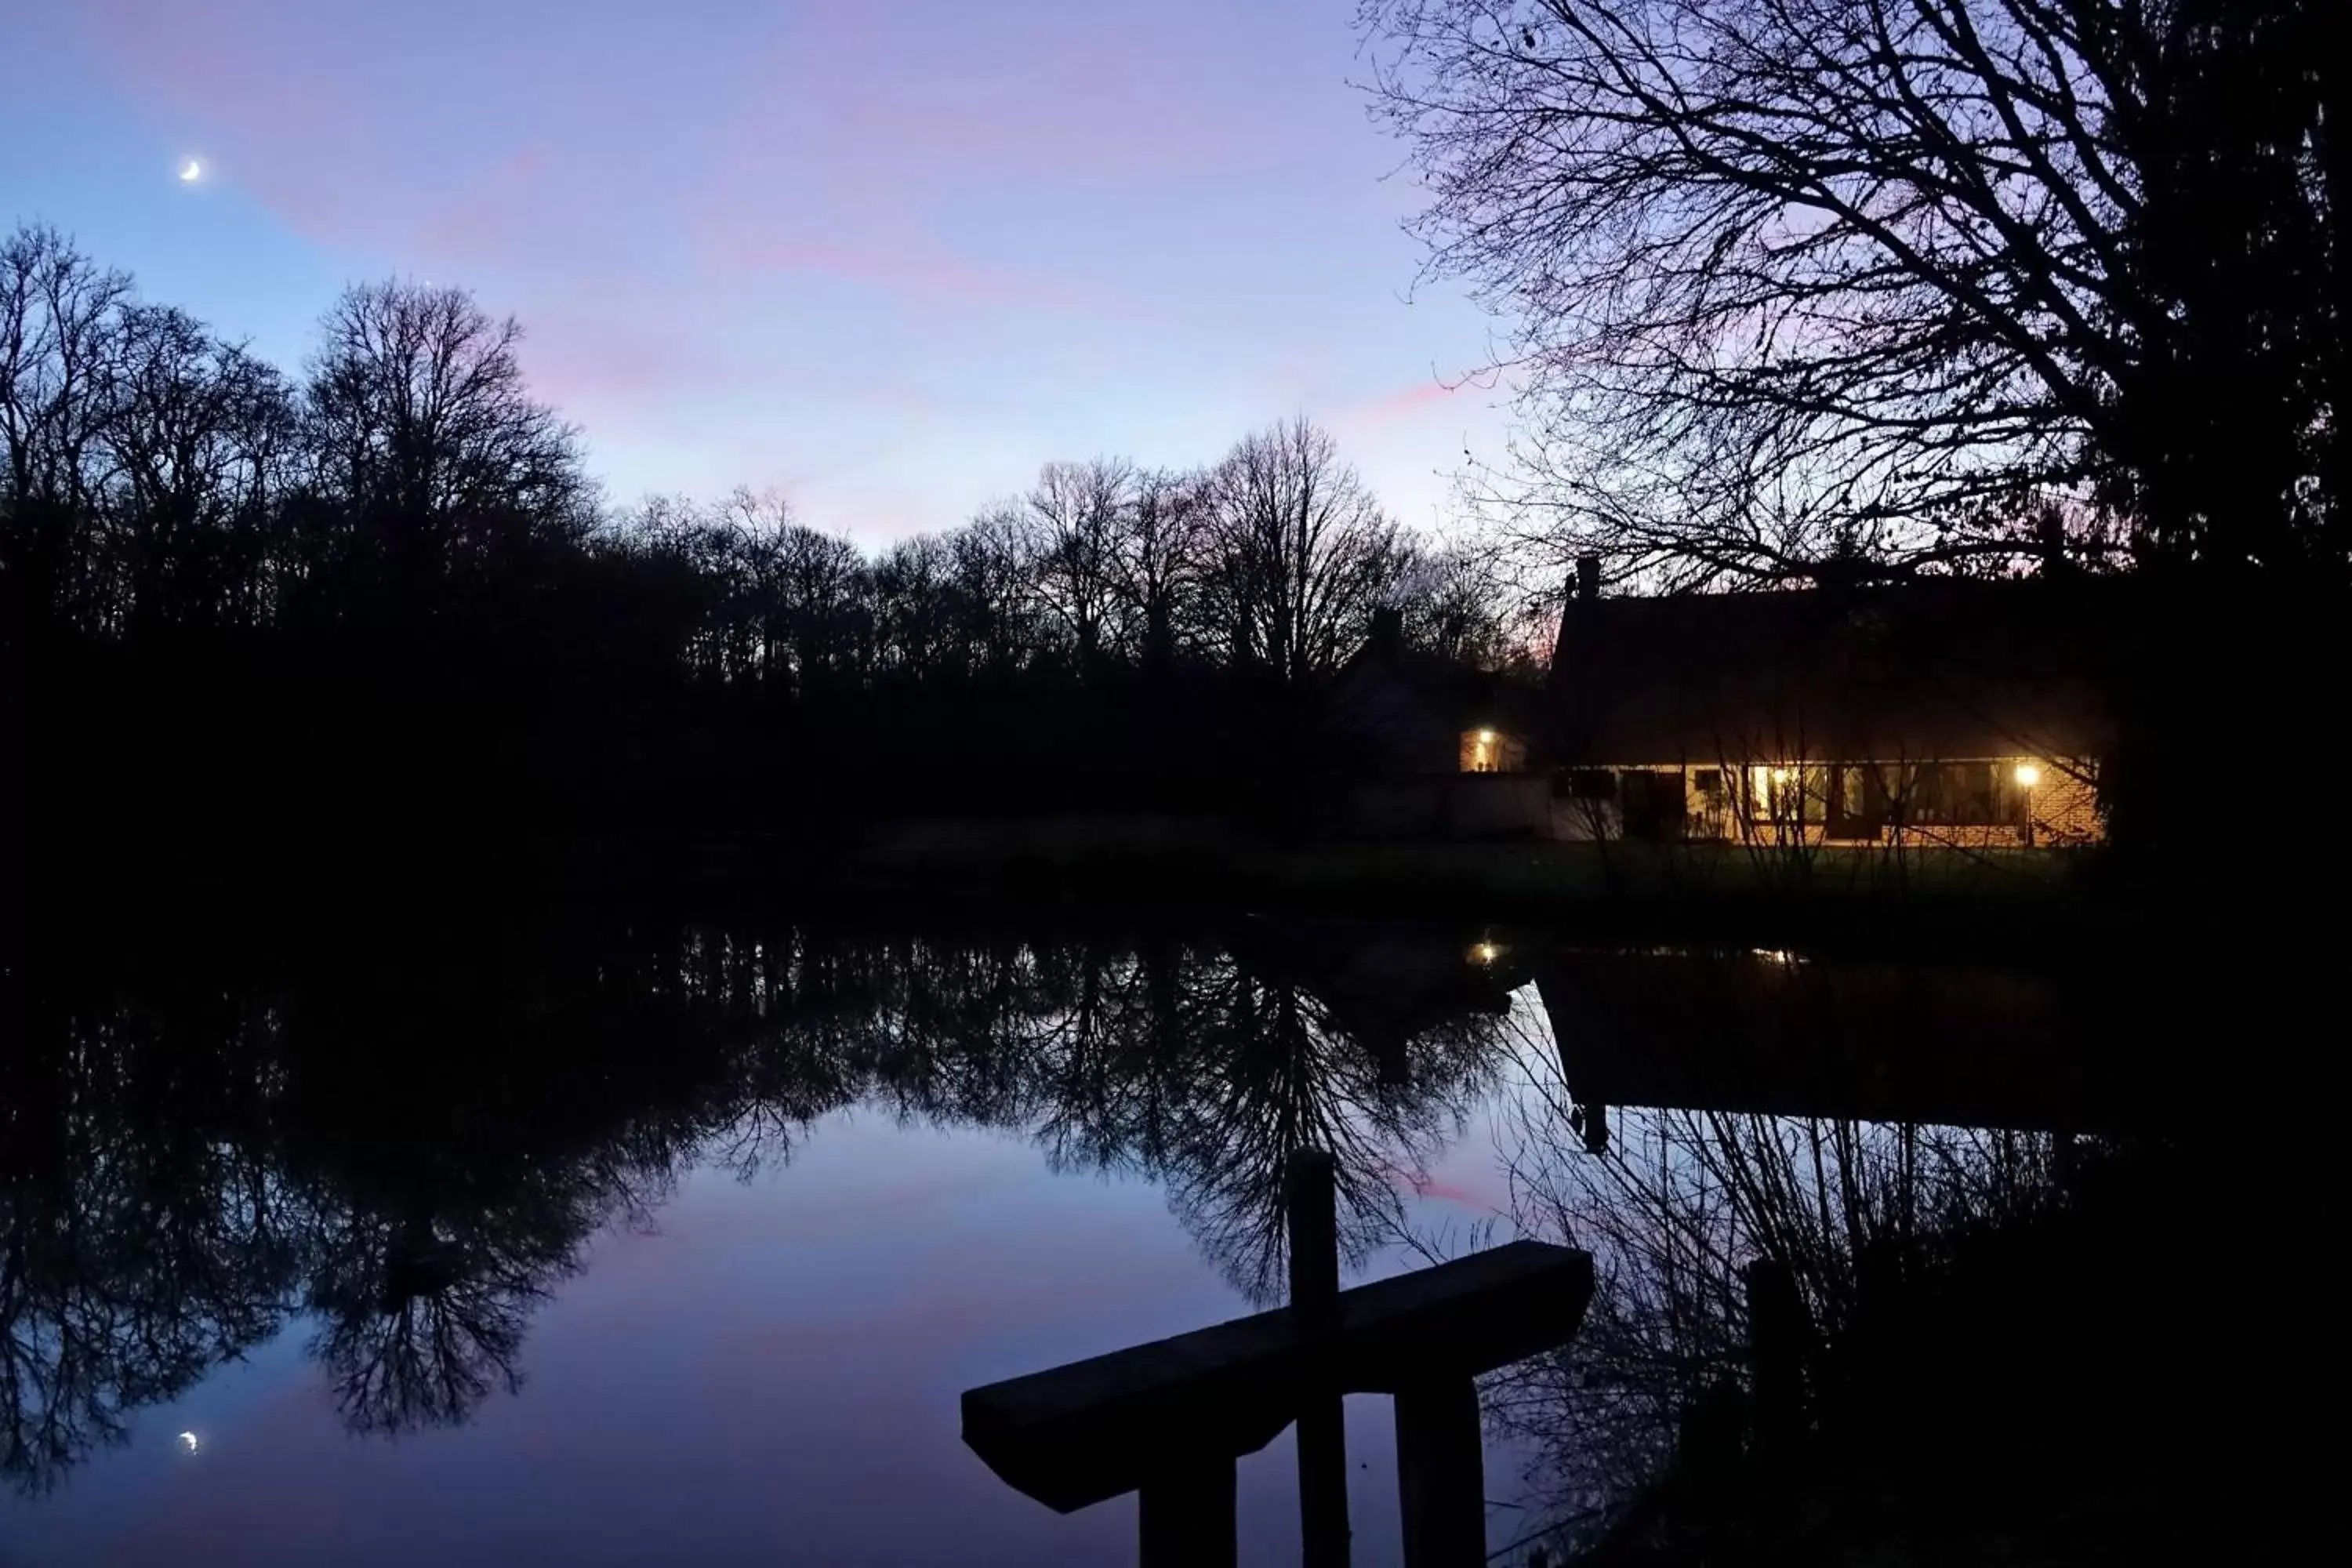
[1541,562,2117,848]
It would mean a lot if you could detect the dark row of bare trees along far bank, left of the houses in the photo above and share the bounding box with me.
[0,226,1519,869]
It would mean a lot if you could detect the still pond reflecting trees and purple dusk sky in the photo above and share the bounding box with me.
[0,916,2296,1568]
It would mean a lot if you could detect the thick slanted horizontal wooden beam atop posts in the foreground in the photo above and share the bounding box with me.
[964,1241,1592,1514]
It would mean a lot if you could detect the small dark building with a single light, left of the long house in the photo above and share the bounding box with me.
[1322,609,1552,839]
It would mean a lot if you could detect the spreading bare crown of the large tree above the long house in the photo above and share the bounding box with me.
[1362,0,2345,583]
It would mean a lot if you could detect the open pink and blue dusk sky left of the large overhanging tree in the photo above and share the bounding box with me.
[0,0,1503,546]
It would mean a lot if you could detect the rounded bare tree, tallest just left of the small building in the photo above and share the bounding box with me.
[1207,419,1409,682]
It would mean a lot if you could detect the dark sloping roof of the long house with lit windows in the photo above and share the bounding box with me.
[1548,579,2117,764]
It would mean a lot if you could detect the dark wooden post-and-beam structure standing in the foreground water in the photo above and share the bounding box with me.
[964,1149,1592,1568]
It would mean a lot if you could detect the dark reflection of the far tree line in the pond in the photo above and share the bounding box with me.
[0,928,1494,1488]
